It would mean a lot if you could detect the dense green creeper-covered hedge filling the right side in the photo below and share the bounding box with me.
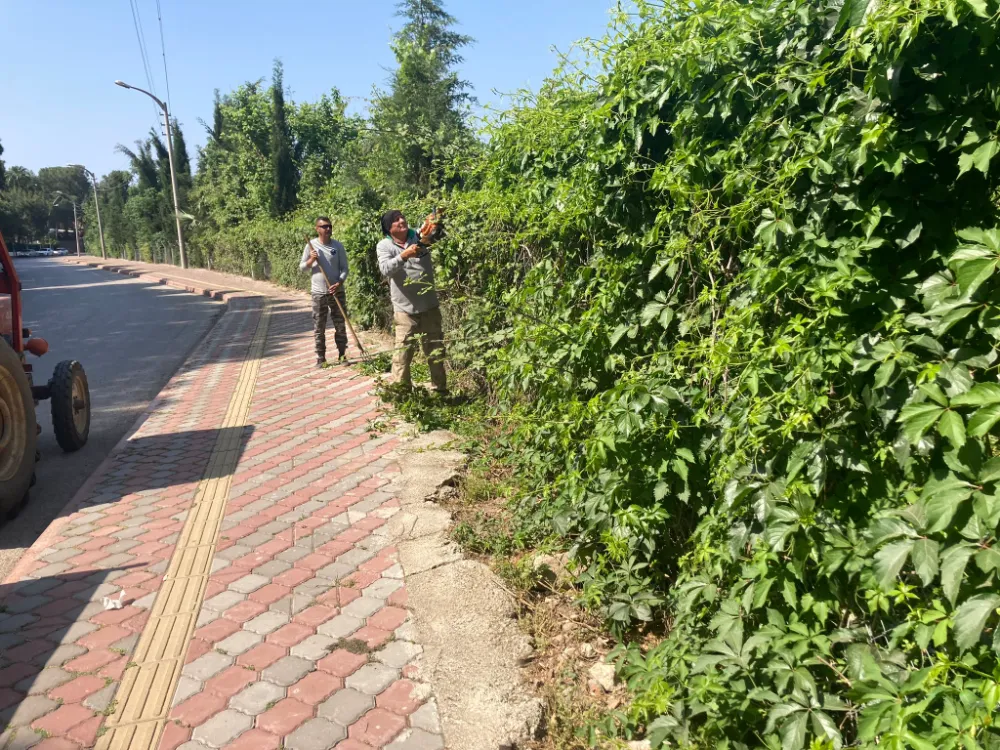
[420,0,1000,750]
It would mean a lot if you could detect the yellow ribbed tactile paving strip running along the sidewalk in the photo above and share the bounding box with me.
[97,300,270,750]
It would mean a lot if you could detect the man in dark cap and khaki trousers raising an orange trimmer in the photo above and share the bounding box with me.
[375,211,448,394]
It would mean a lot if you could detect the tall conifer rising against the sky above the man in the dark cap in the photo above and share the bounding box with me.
[369,0,473,195]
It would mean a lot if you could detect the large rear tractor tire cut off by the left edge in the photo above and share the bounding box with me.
[0,341,38,517]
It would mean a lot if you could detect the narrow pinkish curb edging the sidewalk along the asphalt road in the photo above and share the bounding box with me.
[0,290,264,586]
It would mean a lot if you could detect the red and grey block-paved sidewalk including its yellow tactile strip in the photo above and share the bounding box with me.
[0,280,444,750]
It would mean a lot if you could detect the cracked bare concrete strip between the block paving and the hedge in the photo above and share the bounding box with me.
[385,431,543,750]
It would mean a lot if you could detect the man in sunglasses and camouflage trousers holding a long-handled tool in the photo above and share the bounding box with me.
[299,216,347,367]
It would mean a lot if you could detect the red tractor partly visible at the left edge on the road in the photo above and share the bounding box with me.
[0,235,90,522]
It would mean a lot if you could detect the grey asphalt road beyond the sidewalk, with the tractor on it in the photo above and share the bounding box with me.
[0,258,223,581]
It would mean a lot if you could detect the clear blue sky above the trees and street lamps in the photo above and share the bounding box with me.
[0,0,614,174]
